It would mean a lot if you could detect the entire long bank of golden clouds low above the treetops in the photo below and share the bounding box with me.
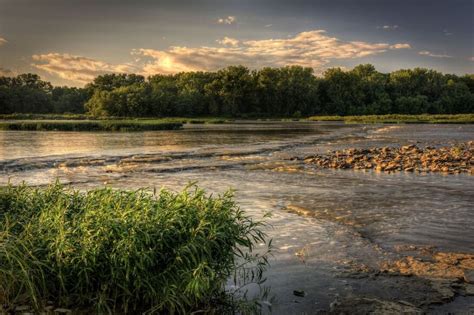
[32,30,410,84]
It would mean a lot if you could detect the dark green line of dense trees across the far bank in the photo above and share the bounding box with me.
[0,64,474,117]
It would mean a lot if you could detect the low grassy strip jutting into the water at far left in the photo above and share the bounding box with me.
[0,120,183,131]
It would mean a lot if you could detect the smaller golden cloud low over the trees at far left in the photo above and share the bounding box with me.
[32,53,137,84]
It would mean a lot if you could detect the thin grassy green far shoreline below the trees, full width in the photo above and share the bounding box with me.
[0,114,474,131]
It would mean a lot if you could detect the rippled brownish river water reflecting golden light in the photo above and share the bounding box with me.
[0,122,474,314]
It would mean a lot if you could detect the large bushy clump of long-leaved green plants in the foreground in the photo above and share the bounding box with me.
[0,184,266,313]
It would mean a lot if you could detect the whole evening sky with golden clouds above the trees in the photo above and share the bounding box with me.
[0,0,474,86]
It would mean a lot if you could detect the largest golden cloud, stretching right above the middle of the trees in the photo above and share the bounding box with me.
[133,30,410,75]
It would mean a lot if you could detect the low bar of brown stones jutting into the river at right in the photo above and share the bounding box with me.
[304,141,474,175]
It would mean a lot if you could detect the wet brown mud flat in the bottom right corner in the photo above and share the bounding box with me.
[286,205,474,314]
